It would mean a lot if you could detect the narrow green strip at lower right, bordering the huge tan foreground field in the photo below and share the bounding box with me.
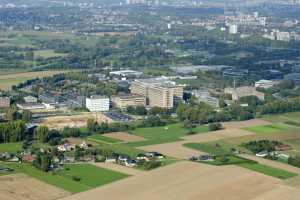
[238,163,298,179]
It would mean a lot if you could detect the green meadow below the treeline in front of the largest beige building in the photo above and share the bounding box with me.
[128,123,209,147]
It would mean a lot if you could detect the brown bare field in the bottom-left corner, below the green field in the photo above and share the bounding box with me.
[0,174,70,200]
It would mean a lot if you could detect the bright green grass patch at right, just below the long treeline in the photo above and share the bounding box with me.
[245,124,291,134]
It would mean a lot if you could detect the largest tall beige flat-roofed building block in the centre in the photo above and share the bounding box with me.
[130,78,183,108]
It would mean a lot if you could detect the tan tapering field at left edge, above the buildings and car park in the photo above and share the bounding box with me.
[0,71,68,90]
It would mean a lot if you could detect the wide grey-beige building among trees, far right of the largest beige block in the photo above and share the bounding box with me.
[225,86,265,101]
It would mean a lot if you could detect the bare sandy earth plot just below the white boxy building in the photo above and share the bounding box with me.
[38,113,112,129]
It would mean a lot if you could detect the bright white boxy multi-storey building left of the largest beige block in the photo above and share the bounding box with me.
[86,96,109,112]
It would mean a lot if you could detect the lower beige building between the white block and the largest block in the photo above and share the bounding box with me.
[111,94,146,109]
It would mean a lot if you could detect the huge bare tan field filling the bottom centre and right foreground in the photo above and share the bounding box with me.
[58,161,300,200]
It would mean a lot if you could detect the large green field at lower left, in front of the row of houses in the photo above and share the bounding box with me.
[5,163,128,193]
